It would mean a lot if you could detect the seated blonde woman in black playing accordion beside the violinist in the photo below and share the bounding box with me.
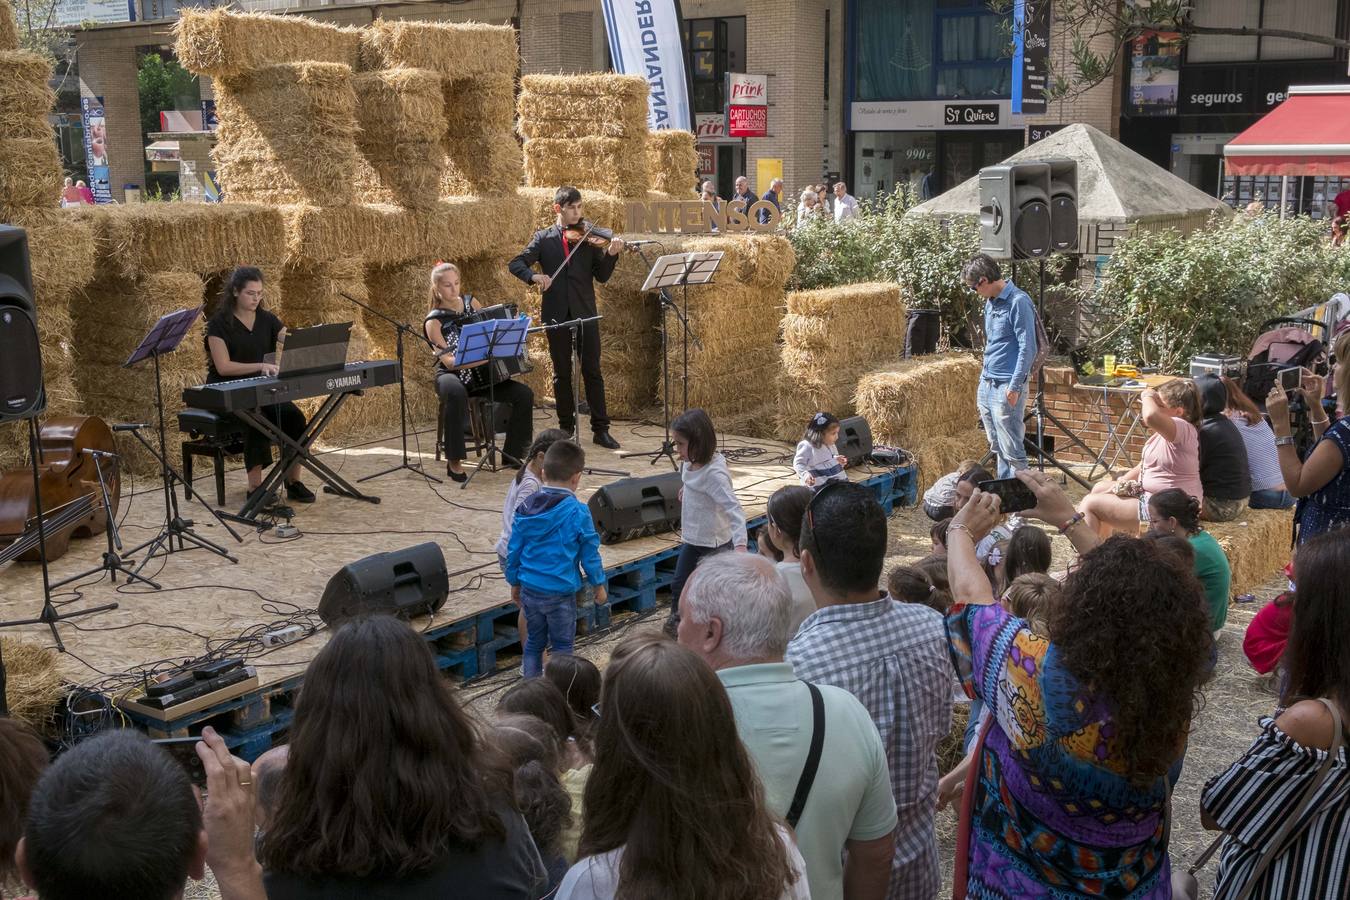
[423,263,535,482]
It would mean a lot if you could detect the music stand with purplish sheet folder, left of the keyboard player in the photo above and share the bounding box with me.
[122,306,244,575]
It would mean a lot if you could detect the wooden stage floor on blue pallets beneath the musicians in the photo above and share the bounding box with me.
[0,410,915,757]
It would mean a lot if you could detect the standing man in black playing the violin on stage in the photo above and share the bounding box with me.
[510,188,624,449]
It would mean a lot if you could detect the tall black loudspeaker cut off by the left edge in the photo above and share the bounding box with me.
[0,225,47,422]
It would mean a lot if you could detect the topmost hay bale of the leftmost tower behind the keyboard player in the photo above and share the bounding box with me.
[174,7,360,78]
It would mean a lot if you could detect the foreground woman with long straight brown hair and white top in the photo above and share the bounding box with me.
[558,636,810,900]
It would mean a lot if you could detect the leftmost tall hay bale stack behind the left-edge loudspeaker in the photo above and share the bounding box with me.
[0,7,93,468]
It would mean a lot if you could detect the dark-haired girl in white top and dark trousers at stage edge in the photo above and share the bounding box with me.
[666,409,748,636]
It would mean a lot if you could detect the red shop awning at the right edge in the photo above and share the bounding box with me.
[1223,85,1350,175]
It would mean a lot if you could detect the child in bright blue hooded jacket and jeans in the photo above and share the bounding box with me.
[506,441,608,679]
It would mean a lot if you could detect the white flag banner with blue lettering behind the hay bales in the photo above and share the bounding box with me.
[601,0,694,131]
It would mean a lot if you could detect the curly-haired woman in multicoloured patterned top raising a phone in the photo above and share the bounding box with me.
[948,471,1211,900]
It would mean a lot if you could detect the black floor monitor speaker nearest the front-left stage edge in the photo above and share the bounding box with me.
[319,541,450,625]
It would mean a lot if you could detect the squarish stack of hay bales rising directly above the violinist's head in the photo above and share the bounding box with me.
[518,74,652,198]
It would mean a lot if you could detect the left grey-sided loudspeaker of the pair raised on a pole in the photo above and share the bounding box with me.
[980,162,1050,259]
